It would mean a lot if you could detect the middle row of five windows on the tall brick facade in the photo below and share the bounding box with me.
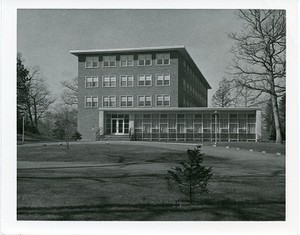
[85,74,170,88]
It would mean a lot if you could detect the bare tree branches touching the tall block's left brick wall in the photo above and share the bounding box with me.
[61,77,78,108]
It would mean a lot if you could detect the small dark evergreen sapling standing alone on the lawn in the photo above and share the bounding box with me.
[167,146,213,204]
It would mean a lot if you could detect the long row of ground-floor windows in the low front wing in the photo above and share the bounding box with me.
[135,113,256,133]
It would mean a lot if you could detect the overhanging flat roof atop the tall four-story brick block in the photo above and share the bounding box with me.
[70,45,211,89]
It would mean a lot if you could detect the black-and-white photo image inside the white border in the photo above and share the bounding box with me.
[1,1,297,234]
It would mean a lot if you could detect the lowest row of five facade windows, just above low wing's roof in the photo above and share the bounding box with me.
[85,95,170,108]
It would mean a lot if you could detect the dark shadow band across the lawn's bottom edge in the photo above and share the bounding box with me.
[17,199,285,221]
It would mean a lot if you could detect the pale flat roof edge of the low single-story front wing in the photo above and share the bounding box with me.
[99,107,261,112]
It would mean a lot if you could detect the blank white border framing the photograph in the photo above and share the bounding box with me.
[0,0,298,235]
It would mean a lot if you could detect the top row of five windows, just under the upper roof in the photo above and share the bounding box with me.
[85,53,170,68]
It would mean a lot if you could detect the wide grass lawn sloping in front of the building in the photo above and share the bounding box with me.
[17,142,285,221]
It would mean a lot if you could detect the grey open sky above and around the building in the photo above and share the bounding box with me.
[17,9,241,104]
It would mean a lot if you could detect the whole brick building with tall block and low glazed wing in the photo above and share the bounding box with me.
[71,46,261,141]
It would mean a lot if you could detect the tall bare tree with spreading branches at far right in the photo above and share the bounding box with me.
[229,10,286,143]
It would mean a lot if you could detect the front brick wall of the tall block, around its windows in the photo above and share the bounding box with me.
[78,49,178,140]
